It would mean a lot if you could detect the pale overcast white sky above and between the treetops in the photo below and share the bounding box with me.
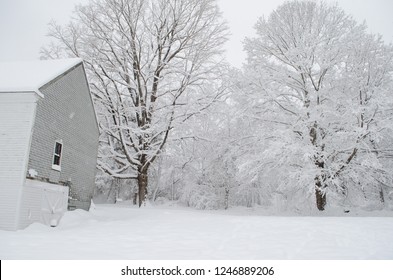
[0,0,393,66]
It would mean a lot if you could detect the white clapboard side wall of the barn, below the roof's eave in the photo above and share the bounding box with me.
[0,92,37,230]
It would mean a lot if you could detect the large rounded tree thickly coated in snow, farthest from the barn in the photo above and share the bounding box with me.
[243,1,393,210]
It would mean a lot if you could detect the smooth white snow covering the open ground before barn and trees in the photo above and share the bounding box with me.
[0,205,393,260]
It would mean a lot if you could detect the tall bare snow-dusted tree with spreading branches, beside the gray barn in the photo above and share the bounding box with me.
[42,0,227,205]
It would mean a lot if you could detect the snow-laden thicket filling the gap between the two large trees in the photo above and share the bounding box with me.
[145,70,242,209]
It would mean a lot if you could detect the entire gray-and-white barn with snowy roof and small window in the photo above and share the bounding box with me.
[0,59,98,230]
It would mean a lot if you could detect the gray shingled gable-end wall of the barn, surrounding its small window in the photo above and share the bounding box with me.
[28,64,99,210]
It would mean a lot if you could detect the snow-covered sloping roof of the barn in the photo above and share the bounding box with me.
[0,58,82,96]
